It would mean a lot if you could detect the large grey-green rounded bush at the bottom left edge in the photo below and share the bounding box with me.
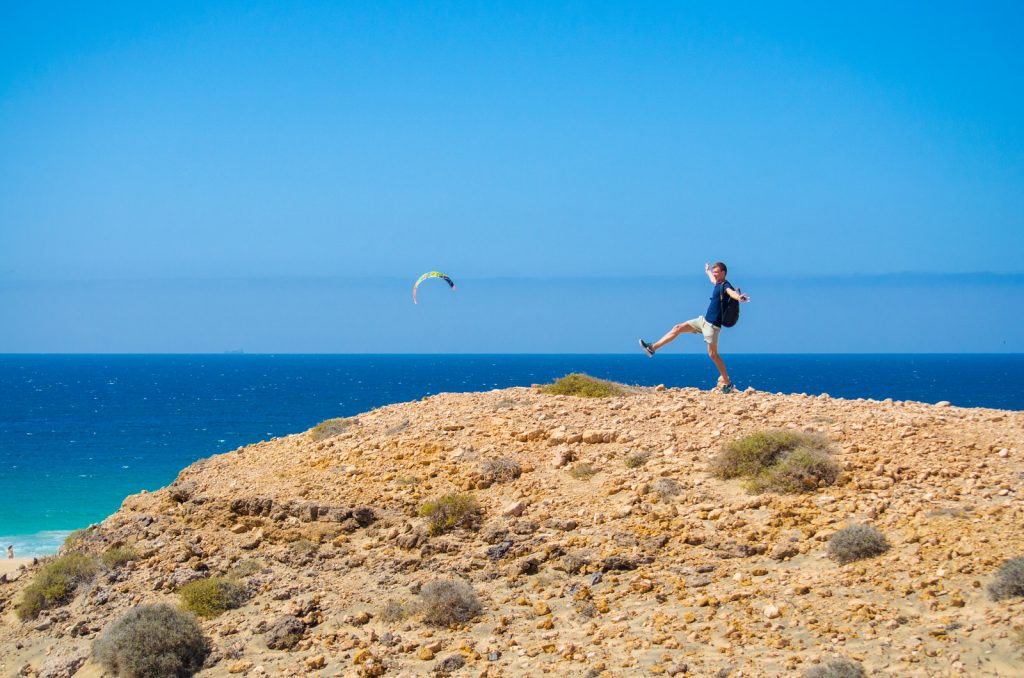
[92,604,210,678]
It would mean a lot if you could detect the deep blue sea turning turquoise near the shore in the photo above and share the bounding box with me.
[0,356,1024,556]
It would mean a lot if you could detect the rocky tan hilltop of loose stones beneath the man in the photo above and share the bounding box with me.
[0,387,1024,676]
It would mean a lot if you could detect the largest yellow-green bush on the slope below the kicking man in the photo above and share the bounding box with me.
[711,431,841,493]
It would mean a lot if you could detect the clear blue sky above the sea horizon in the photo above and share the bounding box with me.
[0,1,1024,352]
